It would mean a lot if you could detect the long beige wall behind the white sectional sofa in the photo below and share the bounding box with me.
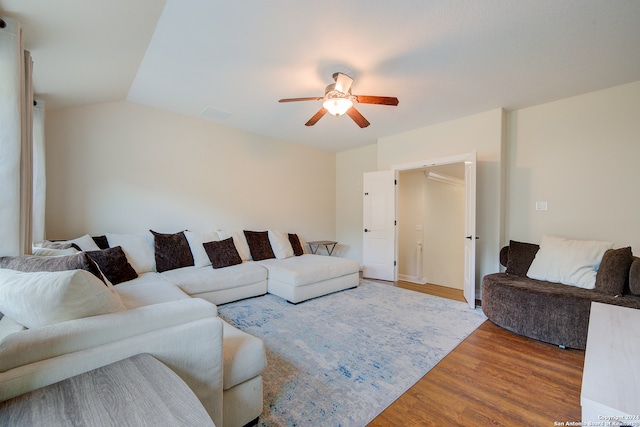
[46,102,336,240]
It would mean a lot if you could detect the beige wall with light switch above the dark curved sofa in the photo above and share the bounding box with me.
[506,82,640,255]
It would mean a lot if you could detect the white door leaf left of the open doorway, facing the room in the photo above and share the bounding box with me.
[362,170,396,280]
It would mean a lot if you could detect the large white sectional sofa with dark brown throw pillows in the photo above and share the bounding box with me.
[0,230,359,427]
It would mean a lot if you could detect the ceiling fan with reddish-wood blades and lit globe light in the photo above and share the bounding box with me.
[278,73,398,128]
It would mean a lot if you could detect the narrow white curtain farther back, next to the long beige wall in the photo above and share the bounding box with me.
[33,99,47,242]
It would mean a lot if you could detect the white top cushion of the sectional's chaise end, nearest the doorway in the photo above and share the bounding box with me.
[258,254,360,286]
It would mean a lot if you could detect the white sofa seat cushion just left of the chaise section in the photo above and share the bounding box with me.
[162,262,267,295]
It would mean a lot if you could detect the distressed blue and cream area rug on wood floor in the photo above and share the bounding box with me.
[218,280,486,427]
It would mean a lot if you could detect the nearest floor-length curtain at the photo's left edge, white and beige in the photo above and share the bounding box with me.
[0,17,33,255]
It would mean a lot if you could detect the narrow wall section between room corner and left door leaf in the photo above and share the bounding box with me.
[335,145,378,263]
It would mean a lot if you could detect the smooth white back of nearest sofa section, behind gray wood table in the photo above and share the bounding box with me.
[0,298,223,425]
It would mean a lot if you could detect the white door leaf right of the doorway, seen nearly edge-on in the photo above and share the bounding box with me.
[464,151,477,308]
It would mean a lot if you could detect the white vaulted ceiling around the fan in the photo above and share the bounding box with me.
[0,0,640,151]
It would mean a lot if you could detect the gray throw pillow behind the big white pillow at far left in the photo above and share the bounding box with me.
[0,252,104,282]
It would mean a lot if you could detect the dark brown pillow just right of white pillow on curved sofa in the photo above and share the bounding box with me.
[596,246,633,295]
